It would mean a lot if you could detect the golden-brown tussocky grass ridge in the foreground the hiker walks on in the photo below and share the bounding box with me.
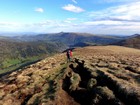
[0,46,140,105]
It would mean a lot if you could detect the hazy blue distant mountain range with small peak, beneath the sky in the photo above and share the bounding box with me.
[11,32,123,46]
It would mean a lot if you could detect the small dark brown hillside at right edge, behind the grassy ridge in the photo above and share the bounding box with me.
[115,34,140,49]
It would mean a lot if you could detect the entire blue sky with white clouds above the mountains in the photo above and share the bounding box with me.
[0,0,140,35]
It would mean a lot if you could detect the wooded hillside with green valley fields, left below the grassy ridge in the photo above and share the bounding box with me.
[0,38,66,73]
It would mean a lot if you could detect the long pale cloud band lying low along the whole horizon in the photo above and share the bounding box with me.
[0,18,140,35]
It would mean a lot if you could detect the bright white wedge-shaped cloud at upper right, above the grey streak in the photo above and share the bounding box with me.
[89,2,140,22]
